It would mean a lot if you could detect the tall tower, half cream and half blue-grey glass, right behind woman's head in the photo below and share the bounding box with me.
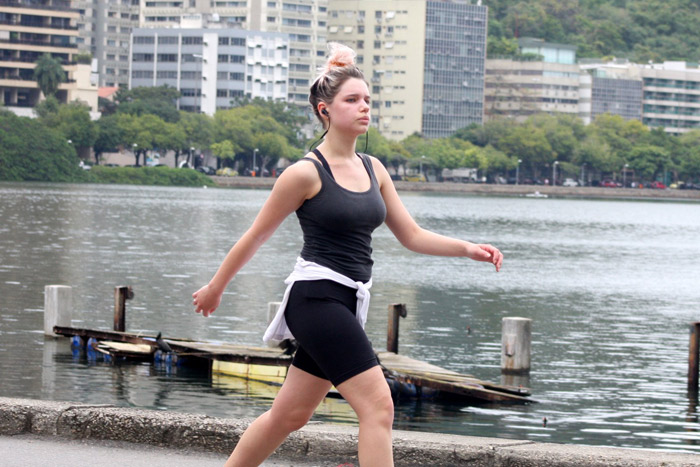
[328,0,488,140]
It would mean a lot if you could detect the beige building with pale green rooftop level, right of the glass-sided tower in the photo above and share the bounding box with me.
[485,38,580,121]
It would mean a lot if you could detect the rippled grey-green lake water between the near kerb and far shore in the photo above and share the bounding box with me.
[0,184,700,452]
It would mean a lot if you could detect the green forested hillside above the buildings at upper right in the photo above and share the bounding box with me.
[483,0,700,63]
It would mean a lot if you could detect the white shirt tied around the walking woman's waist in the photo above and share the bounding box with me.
[263,258,372,342]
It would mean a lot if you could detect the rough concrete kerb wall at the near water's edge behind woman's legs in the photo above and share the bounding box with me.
[0,397,700,467]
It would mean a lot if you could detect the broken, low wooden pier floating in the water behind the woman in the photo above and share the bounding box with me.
[53,326,533,403]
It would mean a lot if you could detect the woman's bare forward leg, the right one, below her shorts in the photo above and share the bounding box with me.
[337,366,394,467]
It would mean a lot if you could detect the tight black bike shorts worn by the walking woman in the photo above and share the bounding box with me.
[284,280,379,387]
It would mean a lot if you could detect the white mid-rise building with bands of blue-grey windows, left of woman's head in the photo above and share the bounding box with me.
[129,28,290,115]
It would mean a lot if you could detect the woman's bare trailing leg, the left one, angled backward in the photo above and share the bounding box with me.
[224,365,332,467]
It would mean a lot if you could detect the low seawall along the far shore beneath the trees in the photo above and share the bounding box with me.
[212,176,700,201]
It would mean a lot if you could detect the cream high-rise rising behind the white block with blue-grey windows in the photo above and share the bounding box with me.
[140,0,328,107]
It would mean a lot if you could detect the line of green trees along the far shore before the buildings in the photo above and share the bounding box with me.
[0,87,700,183]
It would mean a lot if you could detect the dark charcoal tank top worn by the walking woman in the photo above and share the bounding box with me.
[297,149,386,282]
